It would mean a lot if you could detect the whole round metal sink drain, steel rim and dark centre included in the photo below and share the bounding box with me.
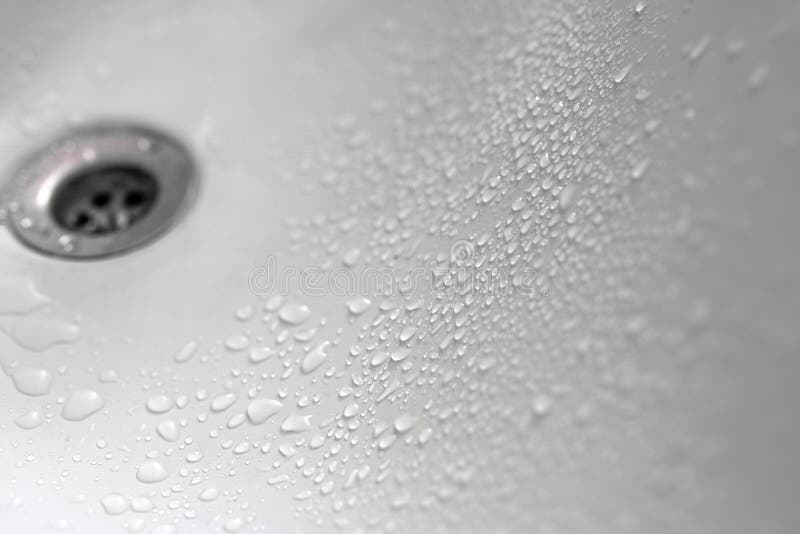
[4,124,196,259]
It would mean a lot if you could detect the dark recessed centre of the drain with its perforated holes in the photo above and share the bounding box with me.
[51,164,159,236]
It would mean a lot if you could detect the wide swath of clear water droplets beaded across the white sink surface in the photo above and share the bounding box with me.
[0,2,788,534]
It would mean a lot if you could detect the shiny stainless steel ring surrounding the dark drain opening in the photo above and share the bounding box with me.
[5,123,197,259]
